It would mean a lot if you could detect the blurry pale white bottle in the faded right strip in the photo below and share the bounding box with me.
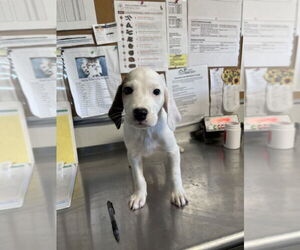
[268,122,296,149]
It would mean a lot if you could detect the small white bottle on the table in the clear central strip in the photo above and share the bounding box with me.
[224,122,242,149]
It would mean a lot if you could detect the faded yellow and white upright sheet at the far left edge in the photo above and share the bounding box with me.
[0,102,34,210]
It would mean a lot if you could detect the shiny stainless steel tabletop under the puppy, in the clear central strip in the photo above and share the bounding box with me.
[57,135,244,250]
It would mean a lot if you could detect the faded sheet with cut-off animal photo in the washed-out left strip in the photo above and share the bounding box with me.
[11,47,56,118]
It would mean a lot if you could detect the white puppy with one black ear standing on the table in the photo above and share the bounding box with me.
[109,68,188,210]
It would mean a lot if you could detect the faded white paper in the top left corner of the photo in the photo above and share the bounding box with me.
[0,0,56,31]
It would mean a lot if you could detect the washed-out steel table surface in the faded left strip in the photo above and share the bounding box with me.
[0,147,56,250]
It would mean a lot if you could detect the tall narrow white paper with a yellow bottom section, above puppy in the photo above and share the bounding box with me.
[167,0,188,68]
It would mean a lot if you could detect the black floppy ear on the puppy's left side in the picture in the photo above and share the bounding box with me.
[108,80,125,129]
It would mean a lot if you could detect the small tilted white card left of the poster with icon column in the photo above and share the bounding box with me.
[93,22,119,45]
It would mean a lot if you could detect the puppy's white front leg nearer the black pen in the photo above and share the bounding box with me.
[128,153,147,210]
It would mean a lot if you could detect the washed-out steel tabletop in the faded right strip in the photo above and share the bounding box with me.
[244,129,300,250]
